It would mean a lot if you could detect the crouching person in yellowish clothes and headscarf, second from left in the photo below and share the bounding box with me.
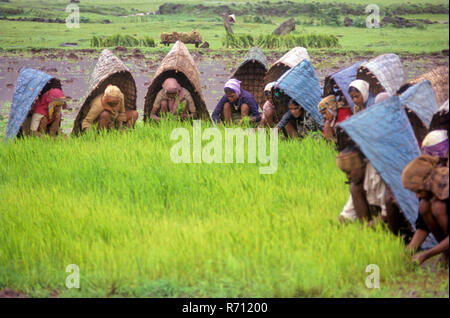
[81,85,138,131]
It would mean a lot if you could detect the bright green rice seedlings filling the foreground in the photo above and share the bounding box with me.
[0,122,448,297]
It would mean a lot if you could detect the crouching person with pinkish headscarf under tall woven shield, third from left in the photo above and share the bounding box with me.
[150,78,197,120]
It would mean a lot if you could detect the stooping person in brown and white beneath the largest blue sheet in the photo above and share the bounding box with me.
[336,145,386,222]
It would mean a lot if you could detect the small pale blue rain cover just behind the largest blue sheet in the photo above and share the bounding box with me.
[400,80,439,127]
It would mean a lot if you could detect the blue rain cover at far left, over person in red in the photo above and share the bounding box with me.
[5,68,53,141]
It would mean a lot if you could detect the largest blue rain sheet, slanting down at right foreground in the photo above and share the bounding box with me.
[339,96,420,228]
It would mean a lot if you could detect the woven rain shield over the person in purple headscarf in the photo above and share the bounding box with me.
[231,47,267,108]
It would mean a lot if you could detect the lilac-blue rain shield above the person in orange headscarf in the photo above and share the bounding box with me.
[323,61,367,111]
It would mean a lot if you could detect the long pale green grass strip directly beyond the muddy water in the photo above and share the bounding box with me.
[0,16,449,53]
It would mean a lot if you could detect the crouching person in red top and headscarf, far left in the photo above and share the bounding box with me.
[30,88,69,137]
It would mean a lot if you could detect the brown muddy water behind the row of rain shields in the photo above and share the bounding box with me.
[0,52,449,133]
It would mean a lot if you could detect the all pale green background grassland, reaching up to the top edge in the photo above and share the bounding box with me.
[0,0,449,53]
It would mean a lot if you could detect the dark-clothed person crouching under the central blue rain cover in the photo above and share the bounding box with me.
[276,99,318,138]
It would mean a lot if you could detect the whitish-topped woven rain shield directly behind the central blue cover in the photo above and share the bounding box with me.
[264,46,309,85]
